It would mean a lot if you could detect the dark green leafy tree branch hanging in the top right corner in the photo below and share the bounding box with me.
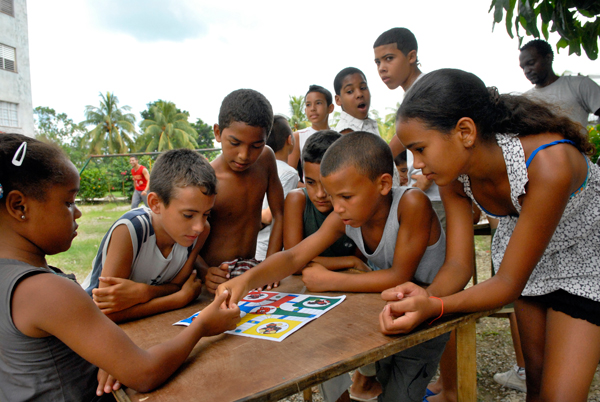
[489,0,600,60]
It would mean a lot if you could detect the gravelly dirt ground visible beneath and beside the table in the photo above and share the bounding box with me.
[281,240,600,402]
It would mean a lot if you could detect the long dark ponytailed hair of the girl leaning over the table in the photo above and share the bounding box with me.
[397,69,594,155]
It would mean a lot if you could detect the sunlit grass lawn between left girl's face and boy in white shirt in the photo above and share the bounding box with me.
[47,203,130,283]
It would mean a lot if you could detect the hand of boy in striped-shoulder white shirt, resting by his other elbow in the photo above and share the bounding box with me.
[92,277,150,314]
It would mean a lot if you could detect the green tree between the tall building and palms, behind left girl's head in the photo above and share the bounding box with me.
[33,106,87,167]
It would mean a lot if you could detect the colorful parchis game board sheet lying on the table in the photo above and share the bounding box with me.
[173,291,346,342]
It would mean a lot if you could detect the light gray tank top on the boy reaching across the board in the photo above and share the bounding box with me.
[346,187,446,284]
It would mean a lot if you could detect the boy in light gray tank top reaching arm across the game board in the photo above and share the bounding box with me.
[217,132,448,402]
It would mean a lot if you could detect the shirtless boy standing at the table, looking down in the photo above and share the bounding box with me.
[200,89,283,293]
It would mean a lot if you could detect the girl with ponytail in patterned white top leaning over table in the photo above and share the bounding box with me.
[380,69,600,402]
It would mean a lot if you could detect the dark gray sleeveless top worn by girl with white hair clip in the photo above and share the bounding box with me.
[0,259,98,402]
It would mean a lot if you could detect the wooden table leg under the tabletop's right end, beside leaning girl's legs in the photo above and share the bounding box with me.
[456,321,477,402]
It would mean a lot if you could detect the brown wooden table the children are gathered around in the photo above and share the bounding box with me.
[115,277,491,402]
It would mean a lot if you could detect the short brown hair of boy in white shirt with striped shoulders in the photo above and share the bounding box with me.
[150,148,217,206]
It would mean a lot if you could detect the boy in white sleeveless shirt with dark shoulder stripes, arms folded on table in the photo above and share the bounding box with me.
[82,149,217,322]
